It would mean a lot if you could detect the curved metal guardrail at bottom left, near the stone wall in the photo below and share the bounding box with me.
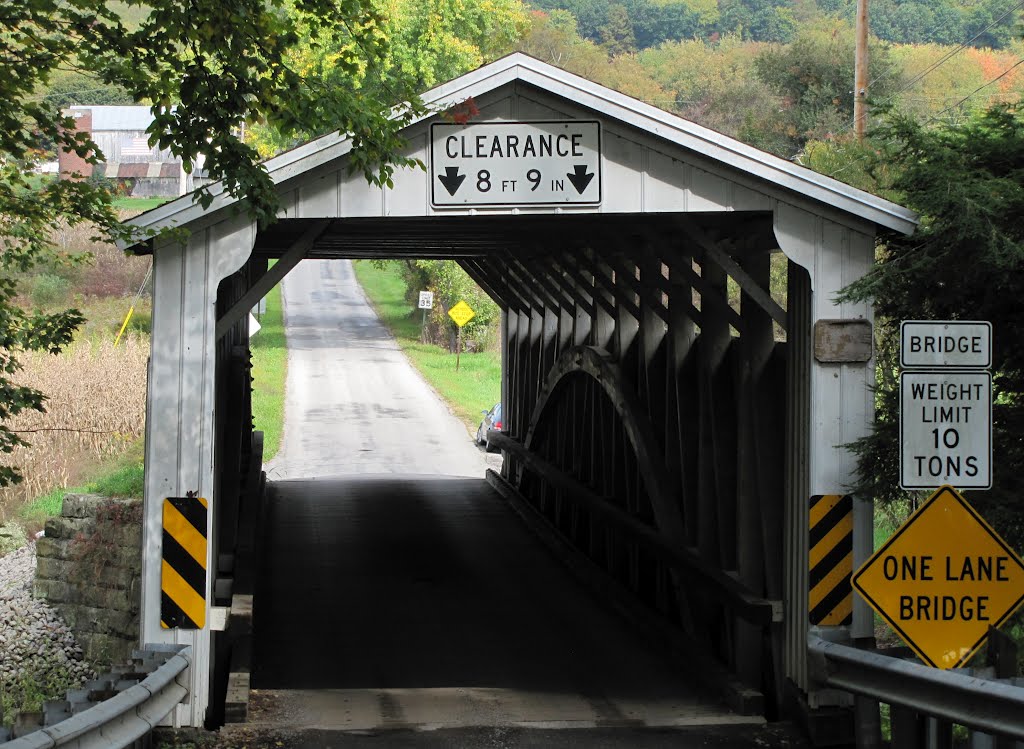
[3,646,191,749]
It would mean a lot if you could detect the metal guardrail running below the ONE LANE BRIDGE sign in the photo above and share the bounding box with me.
[808,635,1024,740]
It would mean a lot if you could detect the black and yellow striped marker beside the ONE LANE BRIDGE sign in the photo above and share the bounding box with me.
[809,494,853,626]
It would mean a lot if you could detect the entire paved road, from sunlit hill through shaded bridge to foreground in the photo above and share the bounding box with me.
[245,261,788,749]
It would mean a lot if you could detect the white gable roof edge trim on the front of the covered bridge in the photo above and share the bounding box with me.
[123,52,918,239]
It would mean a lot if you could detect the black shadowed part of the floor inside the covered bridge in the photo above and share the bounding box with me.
[253,476,694,697]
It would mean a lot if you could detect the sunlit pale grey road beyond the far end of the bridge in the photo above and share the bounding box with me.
[267,260,493,481]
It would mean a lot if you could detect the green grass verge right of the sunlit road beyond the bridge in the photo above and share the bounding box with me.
[354,261,502,428]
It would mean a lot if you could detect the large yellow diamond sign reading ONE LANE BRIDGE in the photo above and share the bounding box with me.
[853,487,1024,668]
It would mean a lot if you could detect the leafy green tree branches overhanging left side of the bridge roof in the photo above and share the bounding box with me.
[0,0,423,486]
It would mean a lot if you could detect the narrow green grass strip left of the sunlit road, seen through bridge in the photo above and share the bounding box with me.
[251,270,288,461]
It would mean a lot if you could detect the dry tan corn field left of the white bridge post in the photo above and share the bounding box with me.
[0,336,150,523]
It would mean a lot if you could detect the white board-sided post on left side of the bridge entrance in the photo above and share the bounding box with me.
[140,217,255,727]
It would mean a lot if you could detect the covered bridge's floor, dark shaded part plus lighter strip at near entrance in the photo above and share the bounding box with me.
[253,475,760,731]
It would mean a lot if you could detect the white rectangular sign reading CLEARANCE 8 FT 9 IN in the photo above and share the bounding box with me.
[430,120,601,208]
